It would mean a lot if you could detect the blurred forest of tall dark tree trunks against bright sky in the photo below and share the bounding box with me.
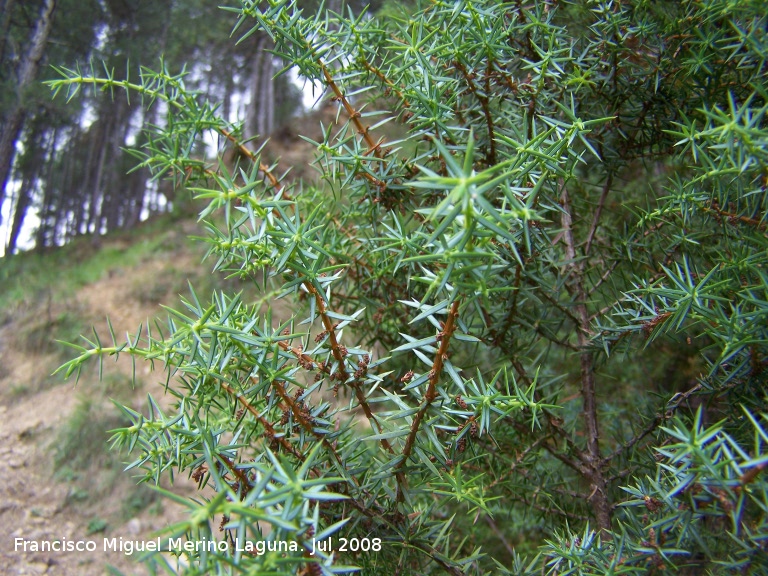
[0,0,384,254]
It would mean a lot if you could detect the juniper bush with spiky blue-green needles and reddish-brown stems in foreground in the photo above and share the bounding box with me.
[53,0,768,574]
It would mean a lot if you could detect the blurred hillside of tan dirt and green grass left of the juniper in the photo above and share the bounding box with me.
[0,219,225,575]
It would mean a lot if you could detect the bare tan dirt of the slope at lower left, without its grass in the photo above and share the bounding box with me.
[0,234,204,576]
